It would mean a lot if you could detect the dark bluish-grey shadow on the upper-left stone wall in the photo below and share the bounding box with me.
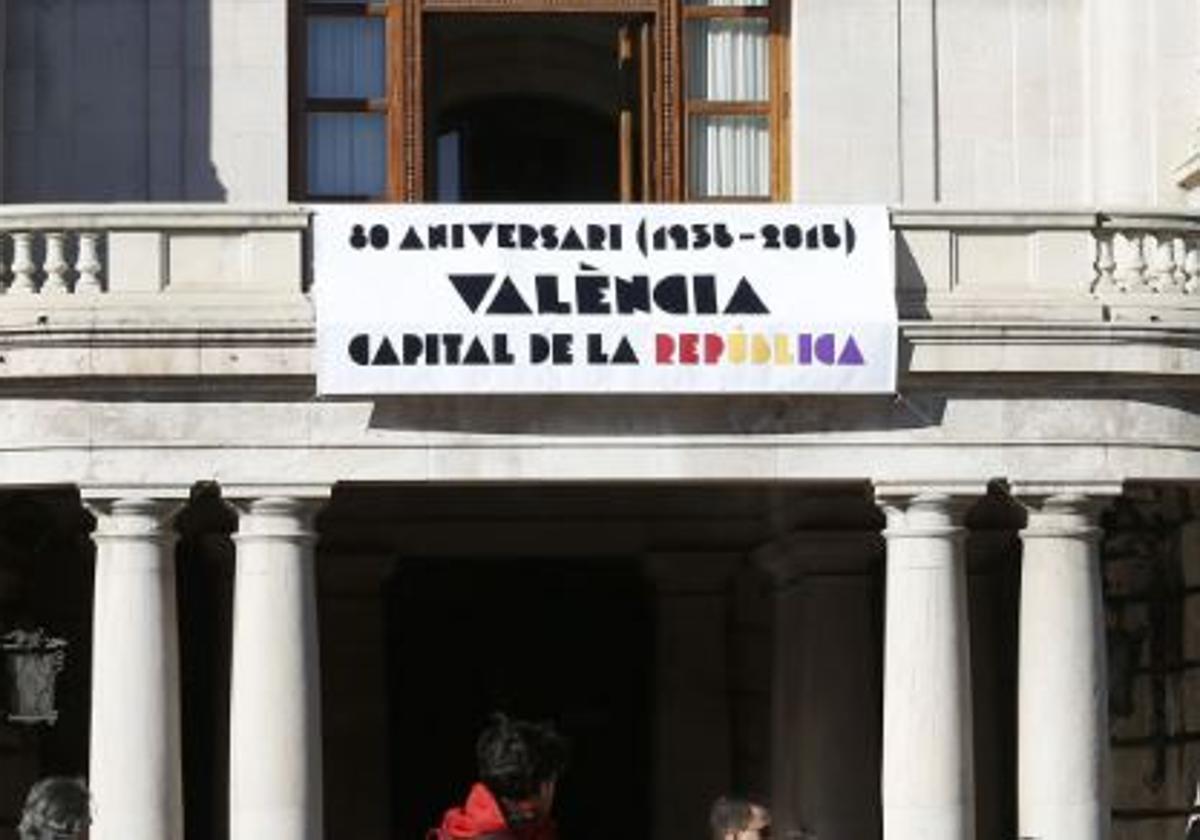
[0,0,226,203]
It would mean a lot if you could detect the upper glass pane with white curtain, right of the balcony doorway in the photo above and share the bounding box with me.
[688,18,770,102]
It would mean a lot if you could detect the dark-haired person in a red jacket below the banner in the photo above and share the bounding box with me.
[430,714,566,840]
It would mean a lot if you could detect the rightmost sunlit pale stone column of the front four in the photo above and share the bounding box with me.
[1018,493,1110,840]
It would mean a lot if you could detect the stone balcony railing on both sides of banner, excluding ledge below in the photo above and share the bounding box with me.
[0,205,1200,322]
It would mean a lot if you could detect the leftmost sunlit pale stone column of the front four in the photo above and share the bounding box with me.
[89,498,184,840]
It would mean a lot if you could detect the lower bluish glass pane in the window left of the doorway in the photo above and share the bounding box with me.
[308,114,388,196]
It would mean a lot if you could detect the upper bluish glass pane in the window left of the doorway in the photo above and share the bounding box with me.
[308,17,385,98]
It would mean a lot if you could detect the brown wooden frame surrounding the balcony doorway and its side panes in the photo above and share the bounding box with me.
[288,0,788,203]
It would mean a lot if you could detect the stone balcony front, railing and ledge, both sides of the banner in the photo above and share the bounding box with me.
[0,205,1200,382]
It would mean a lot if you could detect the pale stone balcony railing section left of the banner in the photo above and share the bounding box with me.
[0,205,308,295]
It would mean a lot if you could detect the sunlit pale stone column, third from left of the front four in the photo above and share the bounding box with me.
[878,490,976,840]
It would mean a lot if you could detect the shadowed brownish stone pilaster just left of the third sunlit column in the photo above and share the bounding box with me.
[755,532,882,838]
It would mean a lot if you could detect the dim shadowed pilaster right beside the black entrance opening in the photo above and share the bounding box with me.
[644,554,738,840]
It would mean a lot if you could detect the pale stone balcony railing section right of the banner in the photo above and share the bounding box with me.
[893,208,1200,322]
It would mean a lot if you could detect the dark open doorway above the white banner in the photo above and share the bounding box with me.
[425,14,634,202]
